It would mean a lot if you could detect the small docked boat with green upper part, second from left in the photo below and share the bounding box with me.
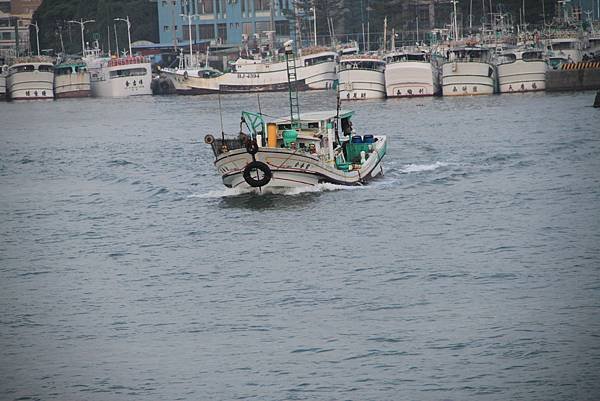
[54,61,92,99]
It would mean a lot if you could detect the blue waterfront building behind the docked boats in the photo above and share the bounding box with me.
[157,0,293,46]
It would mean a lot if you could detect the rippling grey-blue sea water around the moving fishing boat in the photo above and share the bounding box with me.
[0,92,600,401]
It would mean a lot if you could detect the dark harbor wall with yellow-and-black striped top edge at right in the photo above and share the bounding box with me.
[546,63,600,92]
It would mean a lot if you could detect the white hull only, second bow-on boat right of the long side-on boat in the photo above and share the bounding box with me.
[385,61,435,97]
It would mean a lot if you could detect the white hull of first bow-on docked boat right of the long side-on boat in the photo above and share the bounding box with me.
[339,69,386,100]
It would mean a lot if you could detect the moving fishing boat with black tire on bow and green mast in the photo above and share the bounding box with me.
[205,42,387,189]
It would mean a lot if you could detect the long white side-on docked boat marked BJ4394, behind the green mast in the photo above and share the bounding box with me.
[161,51,337,94]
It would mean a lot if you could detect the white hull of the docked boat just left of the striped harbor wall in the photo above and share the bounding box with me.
[498,60,547,93]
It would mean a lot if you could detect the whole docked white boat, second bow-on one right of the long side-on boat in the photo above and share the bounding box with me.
[385,51,435,97]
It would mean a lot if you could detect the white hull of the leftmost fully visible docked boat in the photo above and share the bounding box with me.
[6,71,54,100]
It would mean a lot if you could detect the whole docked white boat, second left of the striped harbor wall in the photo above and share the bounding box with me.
[442,46,496,96]
